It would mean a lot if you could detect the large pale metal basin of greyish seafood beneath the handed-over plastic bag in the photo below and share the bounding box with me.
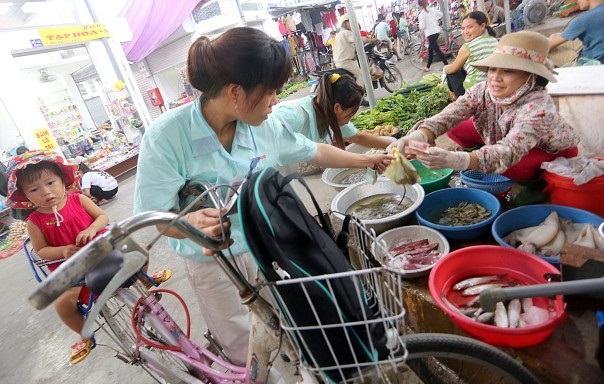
[331,178,424,234]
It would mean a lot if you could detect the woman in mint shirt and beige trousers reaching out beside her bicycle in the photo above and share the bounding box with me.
[134,27,392,364]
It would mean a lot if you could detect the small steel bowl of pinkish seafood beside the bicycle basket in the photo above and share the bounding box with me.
[373,225,450,278]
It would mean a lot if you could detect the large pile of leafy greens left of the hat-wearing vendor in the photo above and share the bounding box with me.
[352,84,451,135]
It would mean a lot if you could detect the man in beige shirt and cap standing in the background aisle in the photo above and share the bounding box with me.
[333,15,379,92]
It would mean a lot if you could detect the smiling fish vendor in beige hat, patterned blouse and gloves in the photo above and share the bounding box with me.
[398,31,579,180]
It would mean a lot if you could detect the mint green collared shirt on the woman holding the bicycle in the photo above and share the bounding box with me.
[134,101,317,261]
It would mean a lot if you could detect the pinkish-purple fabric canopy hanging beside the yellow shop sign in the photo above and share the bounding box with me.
[121,0,209,63]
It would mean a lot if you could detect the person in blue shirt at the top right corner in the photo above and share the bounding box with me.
[549,0,604,65]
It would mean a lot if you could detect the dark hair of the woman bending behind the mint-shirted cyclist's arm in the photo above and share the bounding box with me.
[313,73,365,149]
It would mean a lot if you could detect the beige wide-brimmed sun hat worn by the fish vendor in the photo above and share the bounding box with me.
[470,31,557,83]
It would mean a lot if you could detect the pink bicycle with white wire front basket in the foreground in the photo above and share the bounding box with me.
[29,181,538,383]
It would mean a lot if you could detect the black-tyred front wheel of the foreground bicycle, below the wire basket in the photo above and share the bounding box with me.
[402,333,539,384]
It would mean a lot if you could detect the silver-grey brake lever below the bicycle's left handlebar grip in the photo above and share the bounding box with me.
[80,252,147,339]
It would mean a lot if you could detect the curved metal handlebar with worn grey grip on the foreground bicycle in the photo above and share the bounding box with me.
[28,212,226,309]
